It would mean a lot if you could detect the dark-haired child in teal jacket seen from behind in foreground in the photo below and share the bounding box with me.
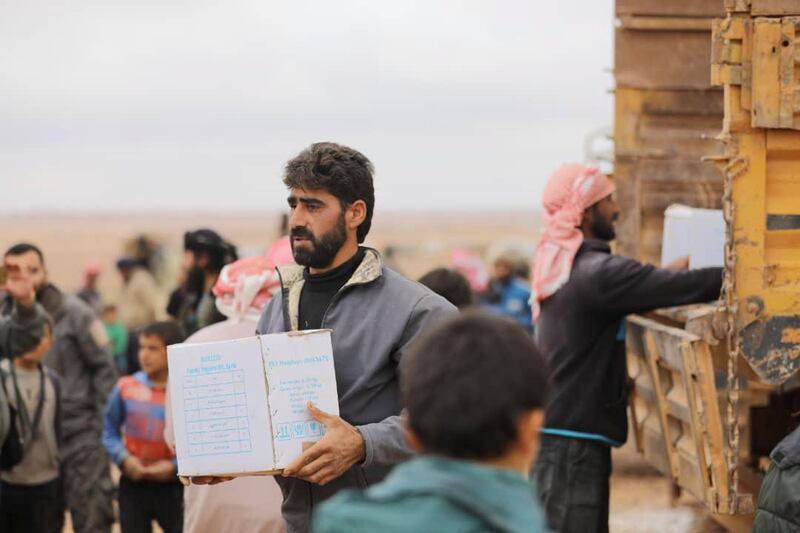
[314,311,548,533]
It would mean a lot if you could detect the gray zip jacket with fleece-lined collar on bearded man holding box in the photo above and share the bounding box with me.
[257,248,457,533]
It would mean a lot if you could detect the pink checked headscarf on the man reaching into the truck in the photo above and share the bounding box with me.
[531,163,616,320]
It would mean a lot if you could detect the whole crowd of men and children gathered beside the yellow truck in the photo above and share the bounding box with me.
[0,143,788,533]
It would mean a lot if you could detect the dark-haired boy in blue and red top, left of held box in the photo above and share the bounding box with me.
[103,322,185,533]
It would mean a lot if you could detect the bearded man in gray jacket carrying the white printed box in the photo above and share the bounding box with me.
[195,143,457,532]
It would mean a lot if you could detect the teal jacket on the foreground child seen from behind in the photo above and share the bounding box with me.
[313,456,547,533]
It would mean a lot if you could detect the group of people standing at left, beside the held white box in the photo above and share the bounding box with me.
[0,224,252,532]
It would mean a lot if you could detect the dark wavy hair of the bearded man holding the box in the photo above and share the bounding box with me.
[283,142,375,243]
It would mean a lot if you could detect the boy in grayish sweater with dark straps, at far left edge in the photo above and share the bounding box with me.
[0,321,64,533]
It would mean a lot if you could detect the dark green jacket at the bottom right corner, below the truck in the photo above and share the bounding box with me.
[753,428,800,533]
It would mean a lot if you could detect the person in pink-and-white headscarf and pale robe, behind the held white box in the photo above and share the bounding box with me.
[164,247,291,533]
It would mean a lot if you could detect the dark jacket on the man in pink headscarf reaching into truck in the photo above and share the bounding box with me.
[535,239,722,445]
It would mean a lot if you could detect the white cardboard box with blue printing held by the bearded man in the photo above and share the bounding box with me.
[167,330,339,476]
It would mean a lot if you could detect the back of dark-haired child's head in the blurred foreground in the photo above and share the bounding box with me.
[402,311,549,473]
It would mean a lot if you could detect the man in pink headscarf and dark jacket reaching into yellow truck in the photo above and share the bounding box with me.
[531,164,722,533]
